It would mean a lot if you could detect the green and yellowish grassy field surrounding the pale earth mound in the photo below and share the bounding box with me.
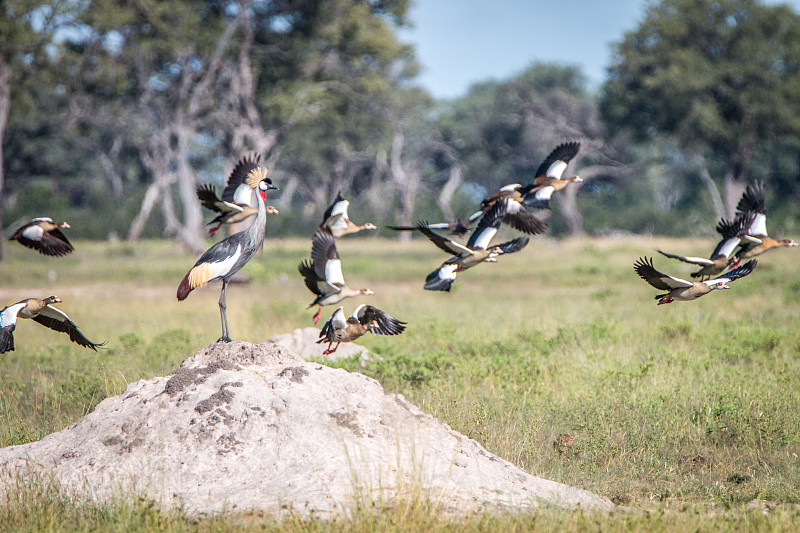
[0,236,800,531]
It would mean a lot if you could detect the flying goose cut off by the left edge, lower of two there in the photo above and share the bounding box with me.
[0,296,105,353]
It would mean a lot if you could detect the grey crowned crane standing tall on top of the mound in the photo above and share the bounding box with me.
[178,167,277,342]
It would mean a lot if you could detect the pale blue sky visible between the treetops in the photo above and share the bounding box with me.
[400,0,800,98]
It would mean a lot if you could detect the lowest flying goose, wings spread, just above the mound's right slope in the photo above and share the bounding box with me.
[317,304,406,355]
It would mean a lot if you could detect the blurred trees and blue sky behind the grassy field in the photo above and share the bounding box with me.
[0,0,800,254]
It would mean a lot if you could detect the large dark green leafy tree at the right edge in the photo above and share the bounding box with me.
[600,0,800,216]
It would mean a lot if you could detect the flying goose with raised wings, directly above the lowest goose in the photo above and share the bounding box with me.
[297,227,375,324]
